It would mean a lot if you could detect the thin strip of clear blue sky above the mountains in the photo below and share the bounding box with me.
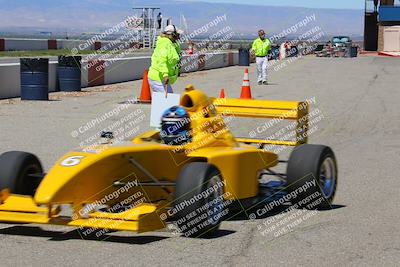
[200,0,365,9]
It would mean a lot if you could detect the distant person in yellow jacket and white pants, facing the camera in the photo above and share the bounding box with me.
[251,30,271,85]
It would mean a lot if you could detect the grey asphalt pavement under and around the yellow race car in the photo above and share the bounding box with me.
[0,57,400,266]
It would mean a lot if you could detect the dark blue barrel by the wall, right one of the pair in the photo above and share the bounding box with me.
[57,56,82,92]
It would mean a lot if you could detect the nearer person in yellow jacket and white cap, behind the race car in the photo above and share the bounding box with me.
[148,25,179,95]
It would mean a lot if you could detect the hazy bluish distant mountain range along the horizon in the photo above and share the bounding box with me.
[0,0,363,36]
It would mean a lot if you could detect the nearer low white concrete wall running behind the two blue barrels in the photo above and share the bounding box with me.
[0,51,239,99]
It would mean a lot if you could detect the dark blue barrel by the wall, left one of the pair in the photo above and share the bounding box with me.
[20,58,49,100]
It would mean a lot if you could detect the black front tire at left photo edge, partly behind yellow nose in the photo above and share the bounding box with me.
[0,151,43,196]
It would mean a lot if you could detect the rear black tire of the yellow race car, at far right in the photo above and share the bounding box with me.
[287,144,338,209]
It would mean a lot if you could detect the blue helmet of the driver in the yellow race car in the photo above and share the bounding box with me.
[160,106,192,145]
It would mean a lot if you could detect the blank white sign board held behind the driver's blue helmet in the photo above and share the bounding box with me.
[150,92,181,128]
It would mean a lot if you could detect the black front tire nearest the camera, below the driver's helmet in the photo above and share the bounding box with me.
[172,162,224,237]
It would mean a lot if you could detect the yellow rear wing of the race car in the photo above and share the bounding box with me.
[213,98,309,147]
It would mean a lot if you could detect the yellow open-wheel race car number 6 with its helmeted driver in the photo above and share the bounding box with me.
[0,86,338,237]
